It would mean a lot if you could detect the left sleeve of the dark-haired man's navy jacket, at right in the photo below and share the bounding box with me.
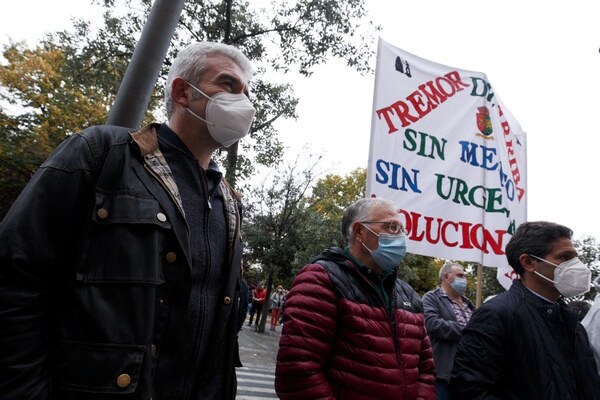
[450,306,508,400]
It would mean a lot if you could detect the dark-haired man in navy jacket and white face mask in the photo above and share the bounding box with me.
[450,222,600,400]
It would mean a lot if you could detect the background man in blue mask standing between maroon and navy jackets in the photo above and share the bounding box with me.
[423,263,475,400]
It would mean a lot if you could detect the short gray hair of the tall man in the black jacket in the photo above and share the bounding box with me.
[165,42,254,118]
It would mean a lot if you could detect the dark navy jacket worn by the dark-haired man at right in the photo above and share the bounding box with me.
[450,280,600,400]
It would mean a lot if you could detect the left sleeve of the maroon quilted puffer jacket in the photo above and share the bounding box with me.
[275,264,337,400]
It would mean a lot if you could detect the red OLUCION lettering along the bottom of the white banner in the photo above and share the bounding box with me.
[398,209,507,255]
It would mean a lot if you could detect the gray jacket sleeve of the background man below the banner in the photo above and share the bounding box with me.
[423,292,463,341]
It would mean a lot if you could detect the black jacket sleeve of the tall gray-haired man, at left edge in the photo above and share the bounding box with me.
[0,135,94,399]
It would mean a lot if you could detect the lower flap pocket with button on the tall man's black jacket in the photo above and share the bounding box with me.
[53,341,145,398]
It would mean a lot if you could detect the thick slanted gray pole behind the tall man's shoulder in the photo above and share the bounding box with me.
[106,0,185,128]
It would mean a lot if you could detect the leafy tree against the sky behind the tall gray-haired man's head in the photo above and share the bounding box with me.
[95,0,379,186]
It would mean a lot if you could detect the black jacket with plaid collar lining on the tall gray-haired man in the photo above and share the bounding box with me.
[0,125,241,399]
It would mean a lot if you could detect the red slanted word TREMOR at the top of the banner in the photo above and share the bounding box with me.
[375,71,470,133]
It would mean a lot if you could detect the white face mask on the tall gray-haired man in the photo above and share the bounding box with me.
[187,82,256,147]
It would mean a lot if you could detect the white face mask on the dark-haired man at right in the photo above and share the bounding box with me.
[530,254,592,297]
